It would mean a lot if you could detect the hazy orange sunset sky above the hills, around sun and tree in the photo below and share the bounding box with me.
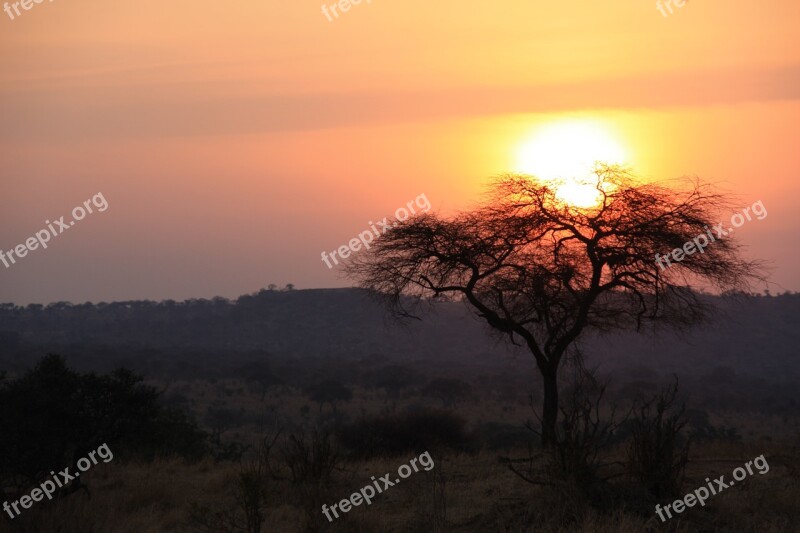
[0,0,800,304]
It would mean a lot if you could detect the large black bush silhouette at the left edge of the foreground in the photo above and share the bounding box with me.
[0,354,205,487]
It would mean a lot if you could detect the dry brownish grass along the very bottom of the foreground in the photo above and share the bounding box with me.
[0,438,800,533]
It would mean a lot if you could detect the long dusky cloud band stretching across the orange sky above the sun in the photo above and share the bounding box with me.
[0,65,800,141]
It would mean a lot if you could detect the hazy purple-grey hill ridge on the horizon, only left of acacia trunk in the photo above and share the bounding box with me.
[0,289,506,358]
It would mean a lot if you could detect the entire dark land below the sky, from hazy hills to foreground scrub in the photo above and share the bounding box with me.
[0,291,800,533]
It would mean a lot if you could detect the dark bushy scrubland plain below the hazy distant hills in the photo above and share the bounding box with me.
[0,350,800,533]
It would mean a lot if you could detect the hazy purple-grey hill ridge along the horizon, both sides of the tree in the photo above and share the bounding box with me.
[0,289,800,381]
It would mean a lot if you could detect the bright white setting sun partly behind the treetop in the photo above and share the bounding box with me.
[514,119,629,208]
